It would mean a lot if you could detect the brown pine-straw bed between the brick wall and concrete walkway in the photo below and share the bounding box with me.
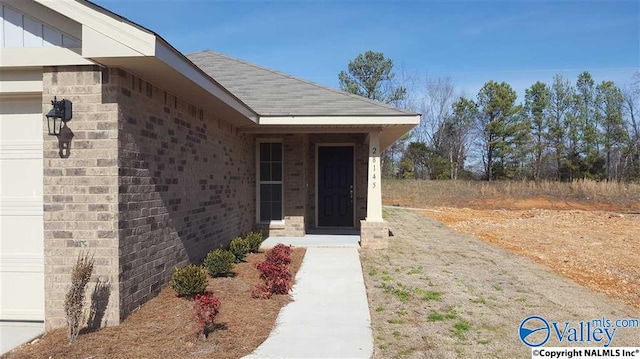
[3,248,305,359]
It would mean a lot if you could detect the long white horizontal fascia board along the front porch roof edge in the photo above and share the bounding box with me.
[258,115,420,126]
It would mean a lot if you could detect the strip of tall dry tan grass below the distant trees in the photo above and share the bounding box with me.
[382,180,640,211]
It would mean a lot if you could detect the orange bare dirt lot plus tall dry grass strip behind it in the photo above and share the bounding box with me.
[383,180,640,308]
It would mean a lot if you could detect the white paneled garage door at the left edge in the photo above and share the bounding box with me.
[0,96,44,321]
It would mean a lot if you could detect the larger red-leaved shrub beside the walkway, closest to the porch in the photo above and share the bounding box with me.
[251,244,292,298]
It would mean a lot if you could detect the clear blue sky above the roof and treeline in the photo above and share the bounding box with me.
[94,0,640,100]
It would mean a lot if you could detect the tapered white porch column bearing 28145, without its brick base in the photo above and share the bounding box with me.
[367,131,382,222]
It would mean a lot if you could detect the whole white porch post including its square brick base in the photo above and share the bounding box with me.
[360,131,389,248]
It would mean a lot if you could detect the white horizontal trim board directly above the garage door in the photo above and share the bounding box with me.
[0,47,95,68]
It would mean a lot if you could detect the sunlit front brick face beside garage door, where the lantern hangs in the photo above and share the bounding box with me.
[42,66,119,329]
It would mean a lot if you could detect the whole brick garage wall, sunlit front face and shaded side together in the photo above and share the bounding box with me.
[43,66,255,329]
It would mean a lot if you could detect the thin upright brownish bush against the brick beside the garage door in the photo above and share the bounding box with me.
[64,254,94,343]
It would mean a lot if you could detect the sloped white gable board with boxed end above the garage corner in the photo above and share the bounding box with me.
[34,0,156,57]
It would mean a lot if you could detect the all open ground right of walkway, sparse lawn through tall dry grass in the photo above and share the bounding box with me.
[370,180,640,358]
